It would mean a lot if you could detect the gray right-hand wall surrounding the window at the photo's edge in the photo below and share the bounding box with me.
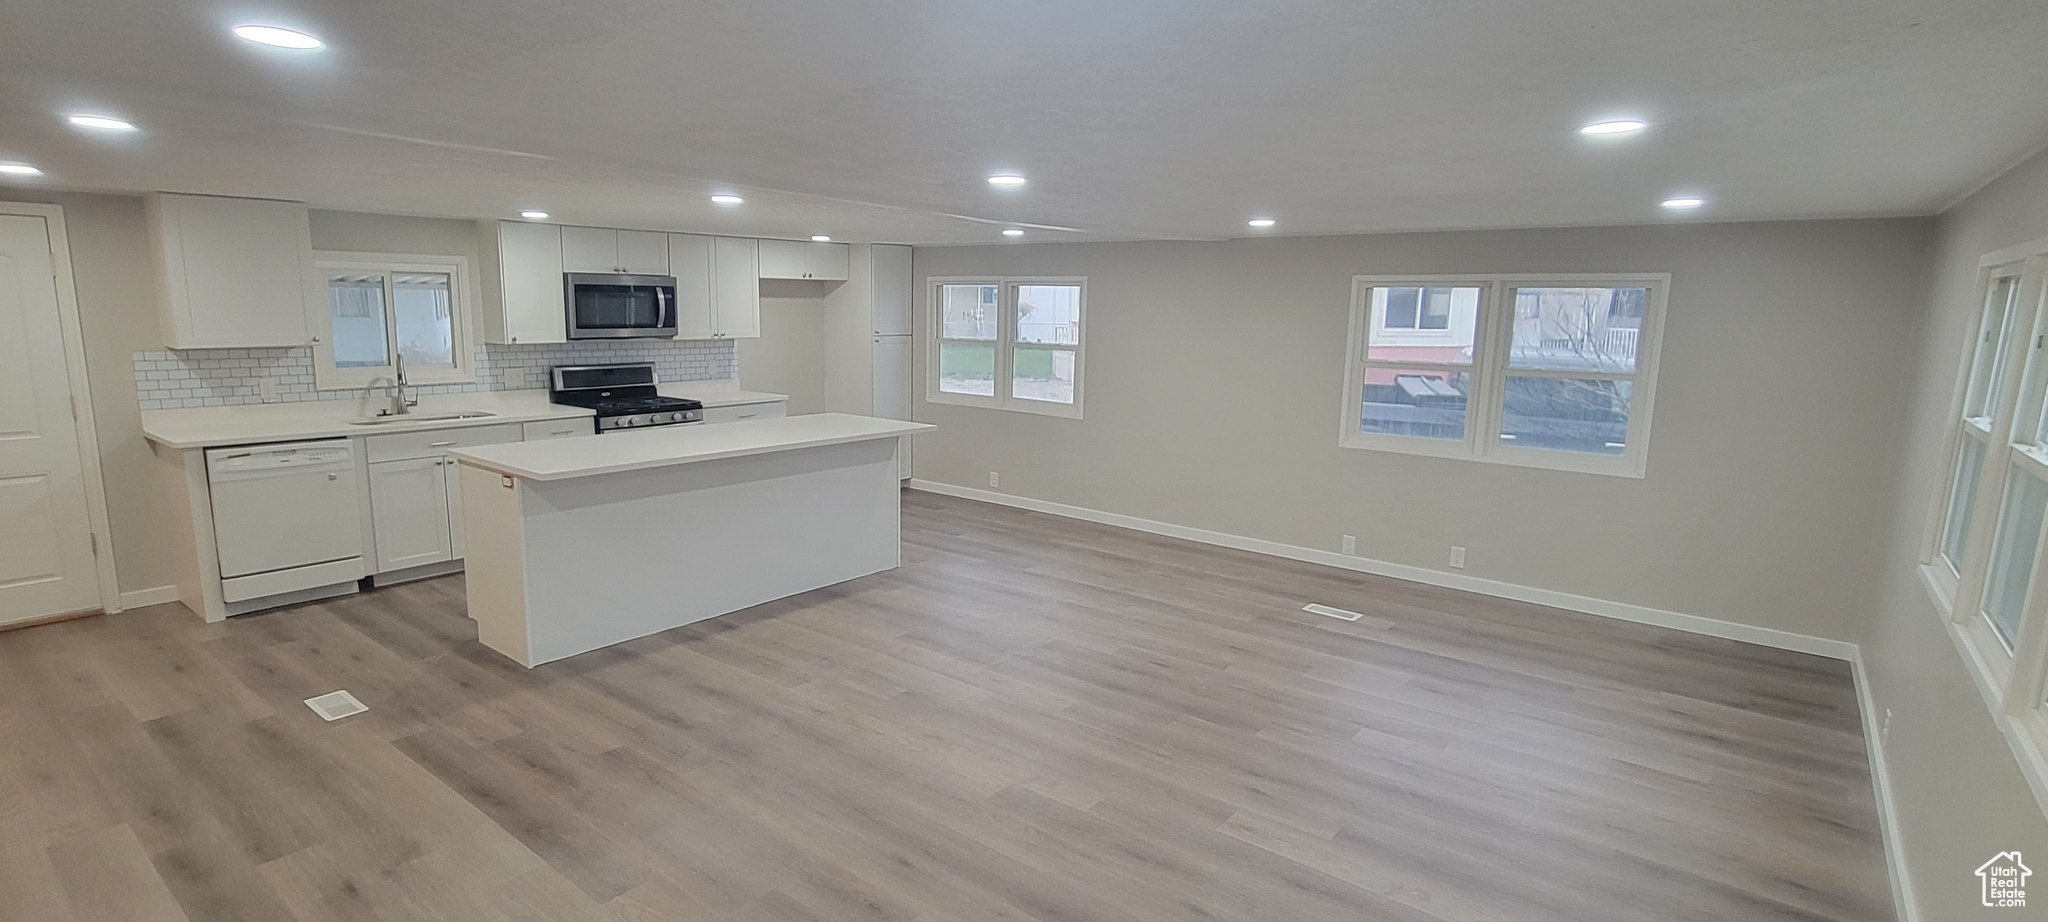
[1860,154,2048,920]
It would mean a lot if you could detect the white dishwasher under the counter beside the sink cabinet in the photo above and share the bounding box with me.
[207,438,362,611]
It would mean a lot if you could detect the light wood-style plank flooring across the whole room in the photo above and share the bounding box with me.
[0,492,1890,922]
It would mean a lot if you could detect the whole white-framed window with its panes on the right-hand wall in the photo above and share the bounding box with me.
[1921,240,2048,809]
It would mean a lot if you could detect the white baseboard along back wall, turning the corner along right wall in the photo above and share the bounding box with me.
[909,477,1919,922]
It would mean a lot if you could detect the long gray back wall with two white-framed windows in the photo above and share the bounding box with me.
[915,219,1931,639]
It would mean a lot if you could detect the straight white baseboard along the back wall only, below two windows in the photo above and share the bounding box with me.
[909,479,1855,660]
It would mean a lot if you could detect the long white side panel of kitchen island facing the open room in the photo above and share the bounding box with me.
[512,434,901,664]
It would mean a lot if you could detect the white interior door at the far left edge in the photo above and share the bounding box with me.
[0,215,100,625]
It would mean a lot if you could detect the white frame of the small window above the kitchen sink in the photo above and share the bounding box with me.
[305,250,477,391]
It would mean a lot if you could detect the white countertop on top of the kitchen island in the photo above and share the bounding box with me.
[449,414,938,481]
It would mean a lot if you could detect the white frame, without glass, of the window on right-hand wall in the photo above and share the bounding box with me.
[1919,240,2048,813]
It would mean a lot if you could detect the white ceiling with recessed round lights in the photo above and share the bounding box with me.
[0,0,2048,244]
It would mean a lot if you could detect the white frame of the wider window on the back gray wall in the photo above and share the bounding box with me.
[1337,273,1671,477]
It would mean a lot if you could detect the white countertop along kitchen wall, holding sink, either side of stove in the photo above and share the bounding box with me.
[141,381,788,449]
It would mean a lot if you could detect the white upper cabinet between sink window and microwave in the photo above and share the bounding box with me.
[483,221,569,344]
